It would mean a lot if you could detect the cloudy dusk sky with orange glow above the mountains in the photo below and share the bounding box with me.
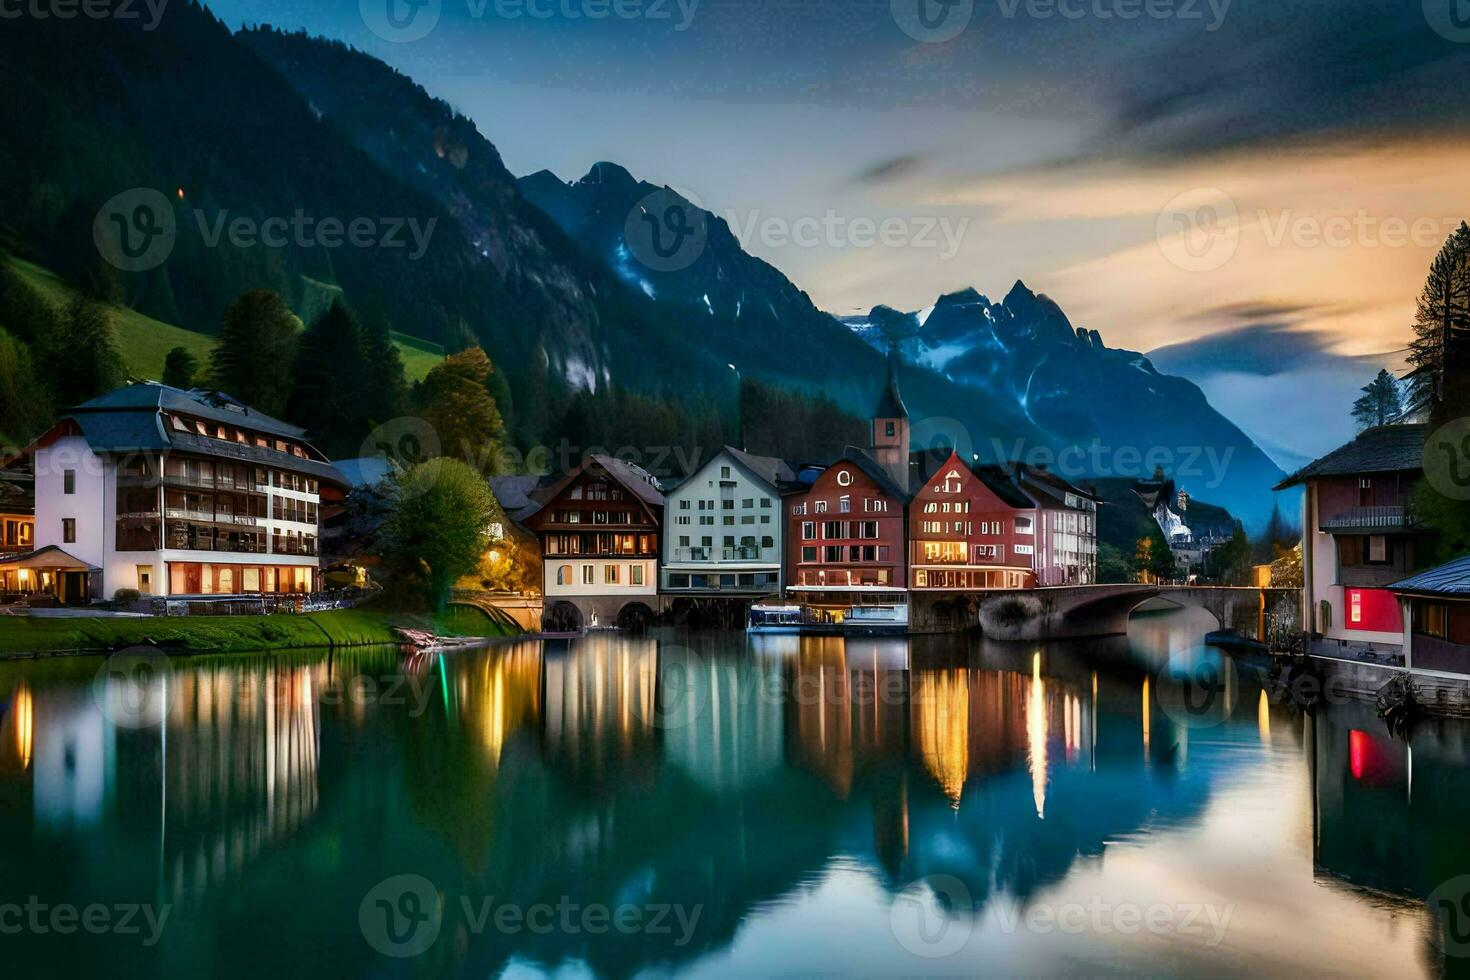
[209,0,1470,469]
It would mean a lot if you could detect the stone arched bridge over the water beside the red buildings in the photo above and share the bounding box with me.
[908,583,1301,639]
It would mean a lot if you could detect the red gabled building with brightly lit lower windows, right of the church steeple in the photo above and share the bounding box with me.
[908,451,1036,592]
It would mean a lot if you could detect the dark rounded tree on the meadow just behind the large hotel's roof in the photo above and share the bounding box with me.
[210,289,301,416]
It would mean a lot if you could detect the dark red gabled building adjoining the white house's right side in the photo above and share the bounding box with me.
[785,450,908,623]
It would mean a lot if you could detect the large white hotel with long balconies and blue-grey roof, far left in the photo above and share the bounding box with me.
[0,382,344,602]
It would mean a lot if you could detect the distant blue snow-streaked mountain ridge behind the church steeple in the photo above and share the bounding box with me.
[845,282,1282,527]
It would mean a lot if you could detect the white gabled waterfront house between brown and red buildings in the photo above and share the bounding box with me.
[662,447,794,598]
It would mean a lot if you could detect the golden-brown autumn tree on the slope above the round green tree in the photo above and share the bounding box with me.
[417,347,506,473]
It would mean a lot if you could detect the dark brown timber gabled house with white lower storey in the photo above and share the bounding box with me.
[520,454,664,629]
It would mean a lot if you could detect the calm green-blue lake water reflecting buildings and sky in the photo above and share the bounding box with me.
[0,613,1470,977]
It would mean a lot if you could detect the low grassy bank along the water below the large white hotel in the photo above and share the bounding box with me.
[0,607,516,660]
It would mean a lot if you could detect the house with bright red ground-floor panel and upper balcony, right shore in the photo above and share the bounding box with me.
[1276,425,1427,661]
